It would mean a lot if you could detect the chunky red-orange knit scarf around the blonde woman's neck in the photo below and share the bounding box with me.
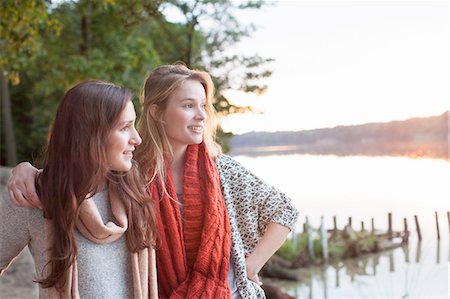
[150,143,231,298]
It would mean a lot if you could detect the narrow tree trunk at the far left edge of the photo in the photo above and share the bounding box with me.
[0,70,17,166]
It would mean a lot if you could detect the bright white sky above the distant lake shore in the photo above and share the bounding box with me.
[216,0,450,134]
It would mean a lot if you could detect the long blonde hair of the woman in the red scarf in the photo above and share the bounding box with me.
[135,64,221,186]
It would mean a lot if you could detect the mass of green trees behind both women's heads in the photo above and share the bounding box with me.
[0,0,271,165]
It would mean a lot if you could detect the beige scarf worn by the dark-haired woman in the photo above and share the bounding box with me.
[45,187,158,299]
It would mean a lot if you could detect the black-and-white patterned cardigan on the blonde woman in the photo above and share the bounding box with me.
[216,155,298,299]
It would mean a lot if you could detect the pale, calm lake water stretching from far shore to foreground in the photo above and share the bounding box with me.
[234,154,450,298]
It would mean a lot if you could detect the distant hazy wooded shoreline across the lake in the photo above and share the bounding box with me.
[231,111,449,160]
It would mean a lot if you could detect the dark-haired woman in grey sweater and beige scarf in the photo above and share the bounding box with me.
[0,81,157,298]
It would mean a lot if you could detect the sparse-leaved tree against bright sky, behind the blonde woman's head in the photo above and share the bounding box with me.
[158,0,273,115]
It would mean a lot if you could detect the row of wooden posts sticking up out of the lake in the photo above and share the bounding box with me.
[293,211,450,260]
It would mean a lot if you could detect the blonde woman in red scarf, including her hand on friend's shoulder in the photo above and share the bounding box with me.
[9,65,298,298]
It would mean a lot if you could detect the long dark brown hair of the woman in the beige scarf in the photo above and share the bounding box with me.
[36,81,156,288]
